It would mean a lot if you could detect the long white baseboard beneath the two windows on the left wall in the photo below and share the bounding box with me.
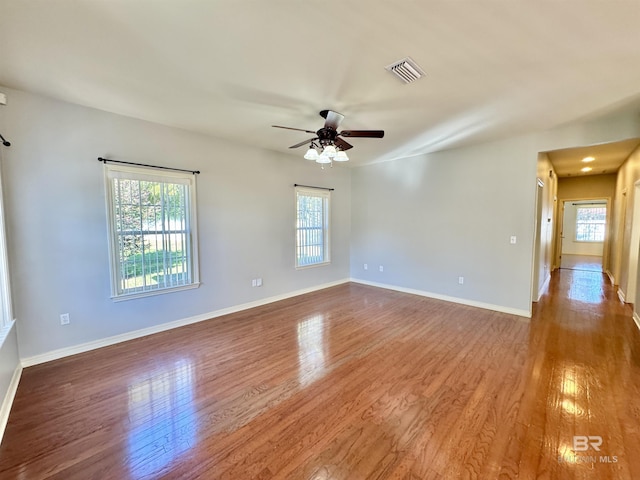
[21,278,349,368]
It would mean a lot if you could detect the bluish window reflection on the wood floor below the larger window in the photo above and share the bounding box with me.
[128,359,196,479]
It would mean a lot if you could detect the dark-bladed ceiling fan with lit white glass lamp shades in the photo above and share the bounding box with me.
[272,110,384,163]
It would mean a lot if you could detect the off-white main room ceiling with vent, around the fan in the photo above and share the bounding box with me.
[0,0,640,164]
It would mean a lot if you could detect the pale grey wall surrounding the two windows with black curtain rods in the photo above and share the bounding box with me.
[0,88,351,358]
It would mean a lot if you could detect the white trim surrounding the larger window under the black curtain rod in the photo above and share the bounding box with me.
[104,163,200,302]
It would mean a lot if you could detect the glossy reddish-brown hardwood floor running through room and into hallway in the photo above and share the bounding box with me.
[0,270,640,480]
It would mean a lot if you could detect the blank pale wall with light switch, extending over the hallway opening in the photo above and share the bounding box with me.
[351,105,640,315]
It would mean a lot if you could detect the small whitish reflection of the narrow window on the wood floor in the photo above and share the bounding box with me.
[298,315,325,386]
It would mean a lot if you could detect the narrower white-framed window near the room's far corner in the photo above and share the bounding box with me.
[296,187,330,268]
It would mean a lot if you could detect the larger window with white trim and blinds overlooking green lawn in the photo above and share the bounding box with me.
[105,165,199,299]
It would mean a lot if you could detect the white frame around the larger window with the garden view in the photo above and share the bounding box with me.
[104,164,200,301]
